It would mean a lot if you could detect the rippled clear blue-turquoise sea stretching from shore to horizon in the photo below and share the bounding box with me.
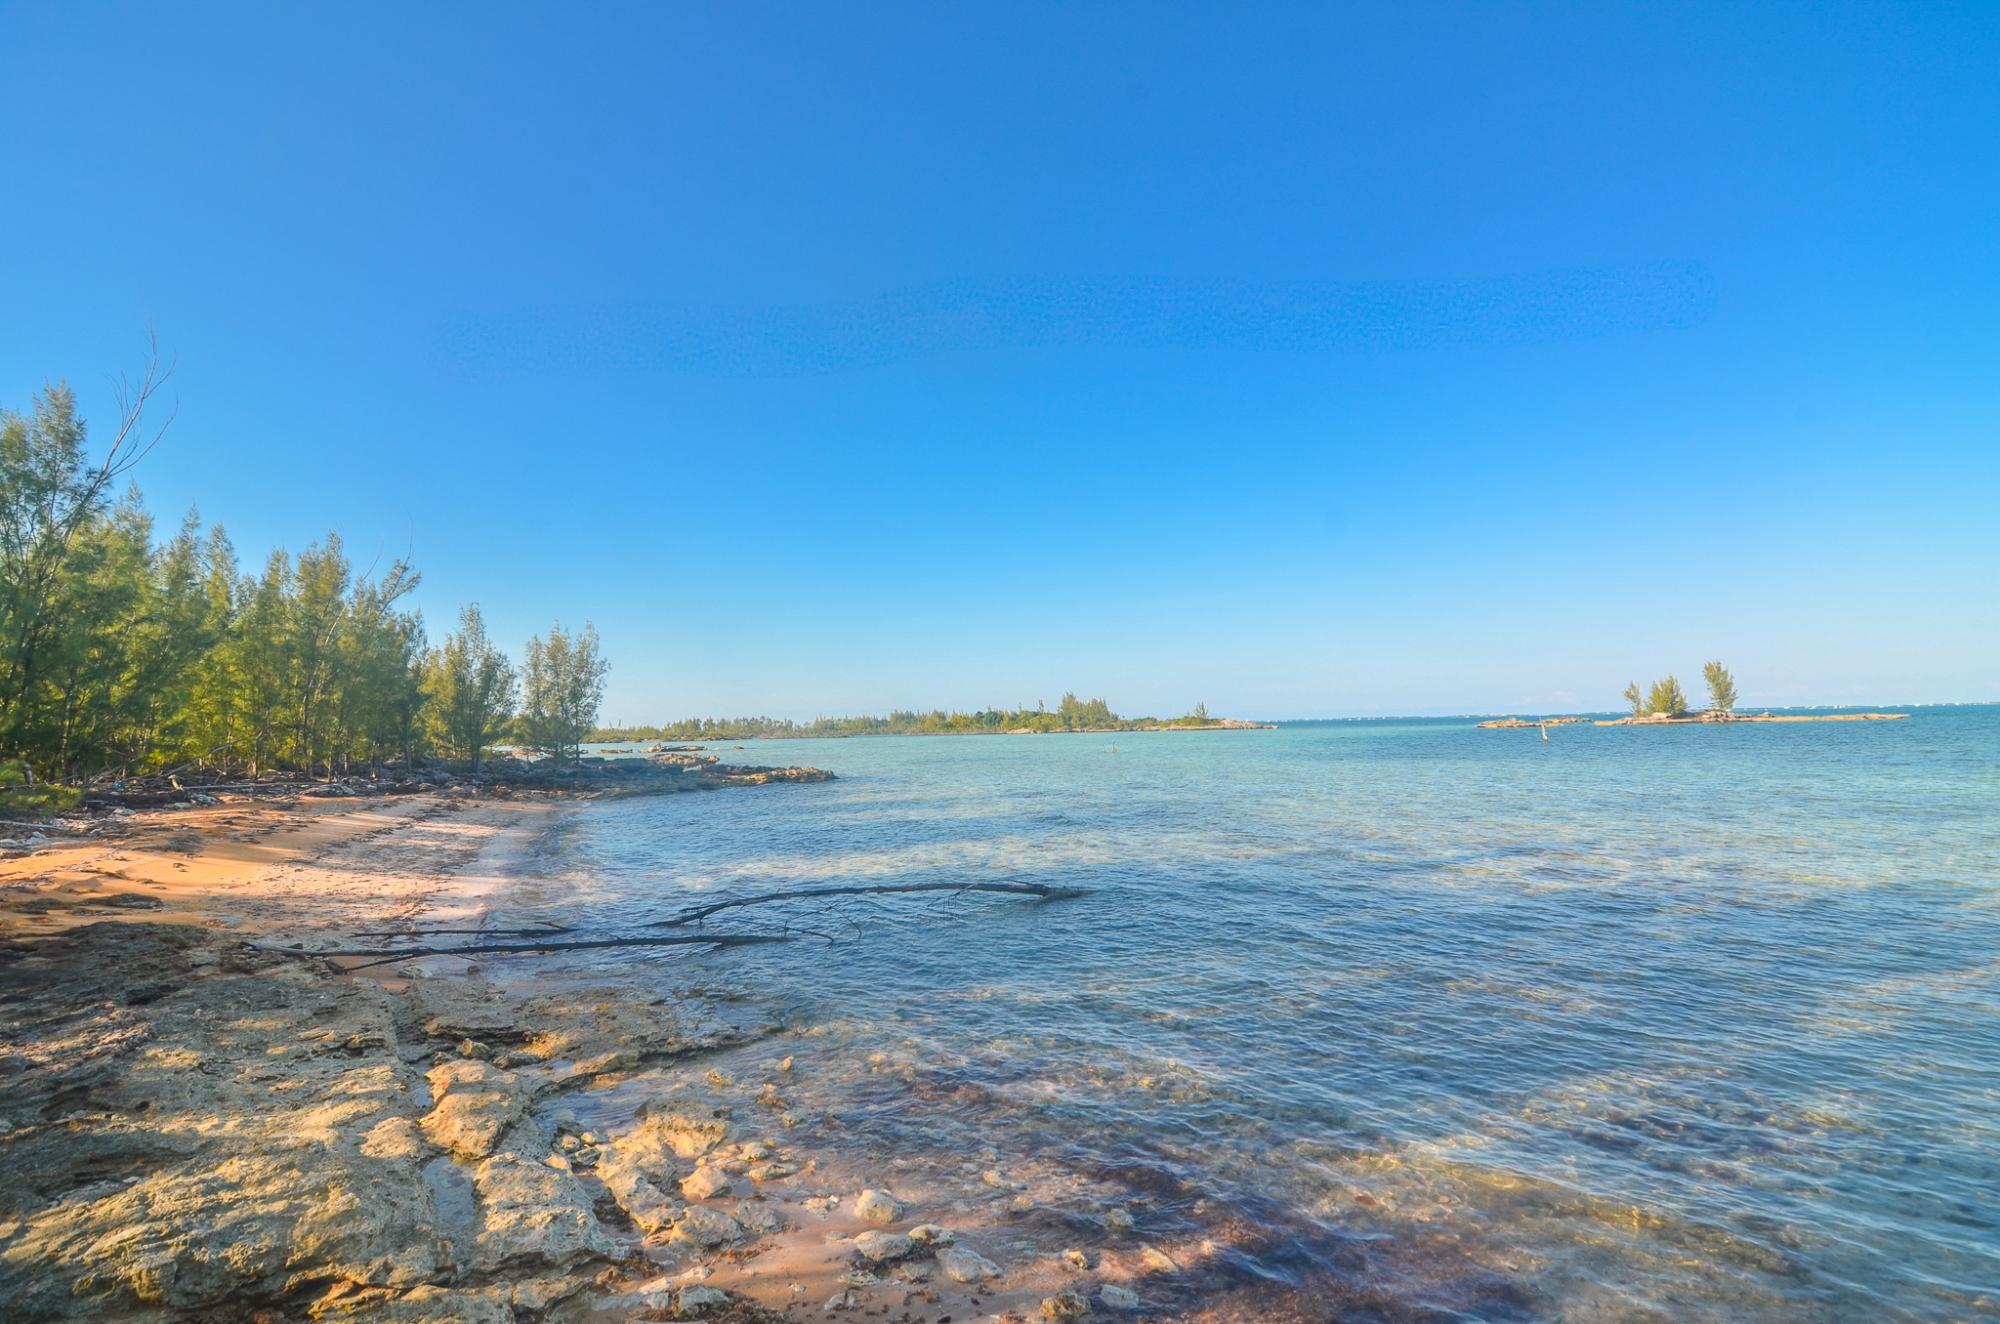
[504,708,2000,1320]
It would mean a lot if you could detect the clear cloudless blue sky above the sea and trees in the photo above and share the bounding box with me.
[0,4,2000,720]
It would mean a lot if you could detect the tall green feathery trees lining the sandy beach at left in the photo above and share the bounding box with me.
[0,360,608,784]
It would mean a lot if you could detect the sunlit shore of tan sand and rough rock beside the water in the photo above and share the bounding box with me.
[0,794,1234,1324]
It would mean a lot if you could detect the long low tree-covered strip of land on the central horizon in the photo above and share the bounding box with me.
[590,694,1276,744]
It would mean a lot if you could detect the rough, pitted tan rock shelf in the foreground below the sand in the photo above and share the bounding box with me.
[0,922,748,1324]
